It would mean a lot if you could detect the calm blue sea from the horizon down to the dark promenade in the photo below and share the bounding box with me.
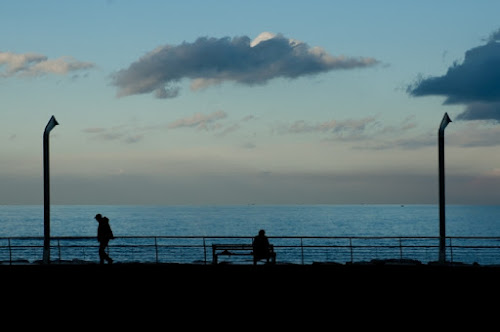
[0,205,500,264]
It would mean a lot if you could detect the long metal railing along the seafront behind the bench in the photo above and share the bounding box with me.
[0,236,500,265]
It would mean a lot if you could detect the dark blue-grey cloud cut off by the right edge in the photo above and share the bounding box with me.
[408,30,500,121]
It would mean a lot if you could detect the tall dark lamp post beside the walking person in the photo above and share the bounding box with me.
[43,115,59,264]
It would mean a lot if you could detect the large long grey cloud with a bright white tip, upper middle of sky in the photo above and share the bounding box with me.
[112,32,378,98]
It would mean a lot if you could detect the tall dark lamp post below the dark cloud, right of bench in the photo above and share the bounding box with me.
[438,113,451,264]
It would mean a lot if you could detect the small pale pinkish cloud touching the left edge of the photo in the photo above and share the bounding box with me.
[0,52,95,78]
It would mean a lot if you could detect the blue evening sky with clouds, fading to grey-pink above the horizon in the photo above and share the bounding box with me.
[0,0,500,205]
